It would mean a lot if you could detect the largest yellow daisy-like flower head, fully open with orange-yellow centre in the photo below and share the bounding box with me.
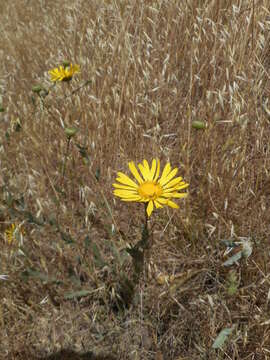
[113,159,189,217]
